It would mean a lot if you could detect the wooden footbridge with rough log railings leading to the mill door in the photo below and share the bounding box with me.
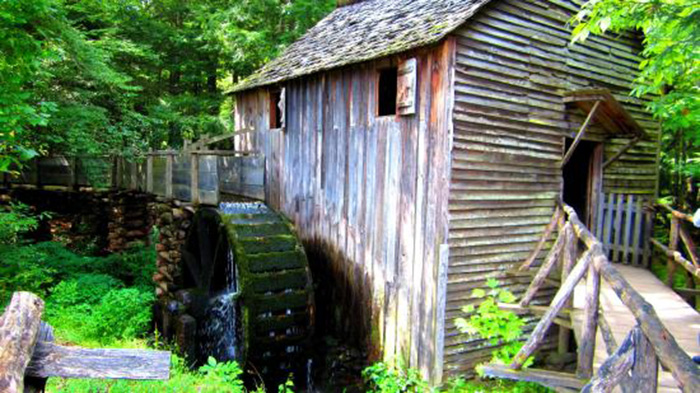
[484,203,700,393]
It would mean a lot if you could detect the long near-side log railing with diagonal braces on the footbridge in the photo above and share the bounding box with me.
[484,203,700,392]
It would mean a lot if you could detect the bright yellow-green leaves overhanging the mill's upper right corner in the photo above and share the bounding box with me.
[574,0,700,133]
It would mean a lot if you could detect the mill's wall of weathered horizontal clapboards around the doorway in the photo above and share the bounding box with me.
[445,0,658,375]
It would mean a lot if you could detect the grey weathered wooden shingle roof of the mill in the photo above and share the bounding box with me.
[231,0,490,92]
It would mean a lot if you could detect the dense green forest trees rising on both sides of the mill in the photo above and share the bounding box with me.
[0,0,700,204]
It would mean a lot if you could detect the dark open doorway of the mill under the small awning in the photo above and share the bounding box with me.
[563,138,602,227]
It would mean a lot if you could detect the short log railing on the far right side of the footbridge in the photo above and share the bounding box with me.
[651,204,700,305]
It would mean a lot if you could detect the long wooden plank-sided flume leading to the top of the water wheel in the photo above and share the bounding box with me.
[4,150,266,205]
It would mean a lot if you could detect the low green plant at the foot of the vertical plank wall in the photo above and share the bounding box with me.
[362,362,428,393]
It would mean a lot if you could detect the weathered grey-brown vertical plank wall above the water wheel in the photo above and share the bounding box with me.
[235,39,454,378]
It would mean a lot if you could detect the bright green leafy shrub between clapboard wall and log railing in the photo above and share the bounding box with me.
[455,279,533,367]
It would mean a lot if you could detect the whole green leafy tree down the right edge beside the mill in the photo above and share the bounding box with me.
[572,0,700,209]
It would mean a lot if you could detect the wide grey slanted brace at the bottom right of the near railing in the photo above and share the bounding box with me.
[581,328,638,393]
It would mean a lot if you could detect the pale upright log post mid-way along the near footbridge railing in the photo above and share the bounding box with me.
[576,255,605,378]
